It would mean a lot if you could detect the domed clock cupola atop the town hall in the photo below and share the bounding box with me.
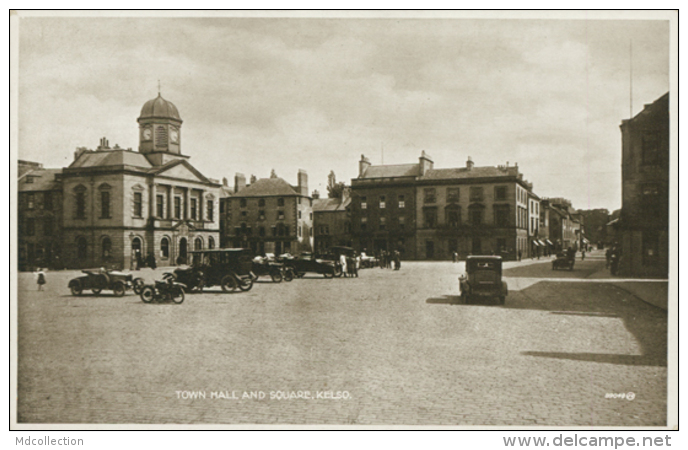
[137,93,183,165]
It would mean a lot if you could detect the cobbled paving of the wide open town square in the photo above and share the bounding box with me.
[18,260,667,426]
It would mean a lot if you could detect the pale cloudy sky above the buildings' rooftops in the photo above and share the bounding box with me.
[18,14,670,211]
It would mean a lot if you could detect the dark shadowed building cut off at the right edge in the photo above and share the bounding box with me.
[617,93,670,277]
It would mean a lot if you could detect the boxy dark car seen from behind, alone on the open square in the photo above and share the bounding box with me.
[459,256,509,305]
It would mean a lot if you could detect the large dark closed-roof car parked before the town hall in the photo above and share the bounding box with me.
[187,248,253,291]
